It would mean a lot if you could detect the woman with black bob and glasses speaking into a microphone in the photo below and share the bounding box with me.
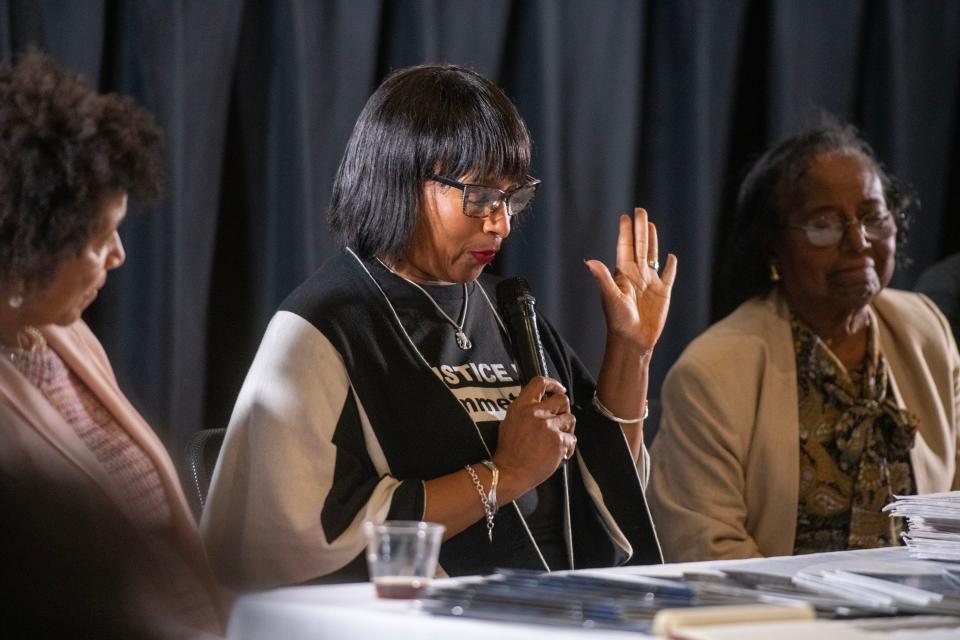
[202,65,676,589]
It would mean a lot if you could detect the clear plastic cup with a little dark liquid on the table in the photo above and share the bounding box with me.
[363,520,444,598]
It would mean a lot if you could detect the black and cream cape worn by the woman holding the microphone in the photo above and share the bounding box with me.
[201,252,661,589]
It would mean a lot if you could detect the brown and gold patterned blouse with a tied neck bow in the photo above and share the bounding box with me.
[791,315,917,554]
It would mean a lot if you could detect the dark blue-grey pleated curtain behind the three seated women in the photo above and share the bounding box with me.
[0,0,960,449]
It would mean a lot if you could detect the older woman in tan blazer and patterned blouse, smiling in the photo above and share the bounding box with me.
[648,123,960,561]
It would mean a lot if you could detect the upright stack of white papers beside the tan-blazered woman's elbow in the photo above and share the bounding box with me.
[884,491,960,562]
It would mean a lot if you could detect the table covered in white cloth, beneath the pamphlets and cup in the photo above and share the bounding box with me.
[227,547,960,640]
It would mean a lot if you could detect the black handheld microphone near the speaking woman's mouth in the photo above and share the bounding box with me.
[497,278,547,385]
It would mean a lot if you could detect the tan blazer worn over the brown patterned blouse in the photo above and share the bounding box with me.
[647,289,960,562]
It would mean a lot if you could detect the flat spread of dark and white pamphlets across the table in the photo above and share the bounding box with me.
[417,547,960,634]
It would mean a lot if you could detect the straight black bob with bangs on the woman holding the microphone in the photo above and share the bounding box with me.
[327,65,531,261]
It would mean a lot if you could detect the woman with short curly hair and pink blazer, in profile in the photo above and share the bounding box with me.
[0,50,220,631]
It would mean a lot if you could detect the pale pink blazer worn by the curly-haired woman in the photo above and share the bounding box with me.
[0,320,223,618]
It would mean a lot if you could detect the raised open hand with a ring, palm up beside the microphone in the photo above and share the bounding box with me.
[585,208,677,351]
